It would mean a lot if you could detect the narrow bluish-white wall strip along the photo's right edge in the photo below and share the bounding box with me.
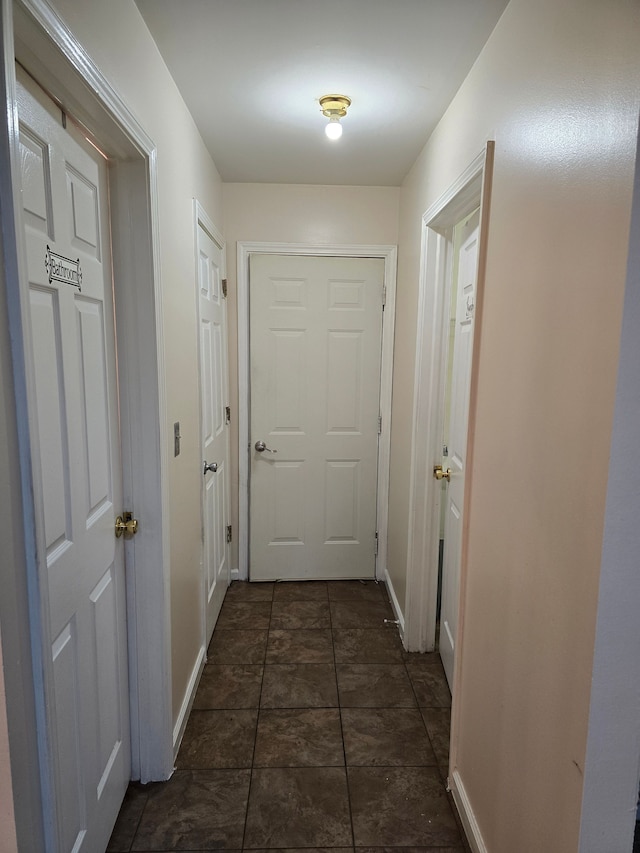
[580,115,640,853]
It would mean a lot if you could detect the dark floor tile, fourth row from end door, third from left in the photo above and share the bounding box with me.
[336,663,416,708]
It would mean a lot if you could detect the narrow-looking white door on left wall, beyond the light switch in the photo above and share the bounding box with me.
[197,219,230,642]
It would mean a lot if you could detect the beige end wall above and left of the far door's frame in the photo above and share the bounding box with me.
[223,184,400,566]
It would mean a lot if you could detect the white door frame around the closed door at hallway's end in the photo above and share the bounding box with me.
[237,241,398,580]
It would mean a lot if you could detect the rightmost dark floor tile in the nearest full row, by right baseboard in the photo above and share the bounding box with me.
[347,767,462,847]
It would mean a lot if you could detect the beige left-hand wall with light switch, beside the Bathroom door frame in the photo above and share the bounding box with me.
[46,0,222,720]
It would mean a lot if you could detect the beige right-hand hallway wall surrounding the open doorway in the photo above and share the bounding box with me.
[390,0,640,853]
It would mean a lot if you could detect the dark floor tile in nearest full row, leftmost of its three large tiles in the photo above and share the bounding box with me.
[131,770,251,851]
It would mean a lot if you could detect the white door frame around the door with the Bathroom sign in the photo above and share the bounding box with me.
[0,0,173,851]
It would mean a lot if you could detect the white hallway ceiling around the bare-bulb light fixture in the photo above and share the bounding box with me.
[136,0,508,186]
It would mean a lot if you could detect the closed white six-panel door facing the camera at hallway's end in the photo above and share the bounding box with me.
[249,254,384,580]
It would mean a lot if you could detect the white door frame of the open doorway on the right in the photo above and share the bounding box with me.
[403,142,494,652]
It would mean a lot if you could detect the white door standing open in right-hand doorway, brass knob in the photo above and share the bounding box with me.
[440,213,480,689]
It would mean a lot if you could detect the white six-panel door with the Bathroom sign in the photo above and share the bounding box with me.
[18,71,130,853]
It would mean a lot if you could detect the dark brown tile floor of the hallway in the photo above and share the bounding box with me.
[108,581,468,853]
